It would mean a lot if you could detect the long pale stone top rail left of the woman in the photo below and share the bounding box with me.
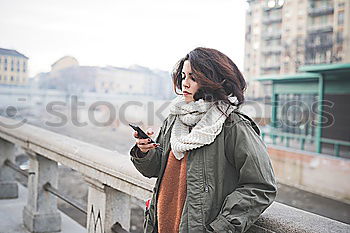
[0,116,155,200]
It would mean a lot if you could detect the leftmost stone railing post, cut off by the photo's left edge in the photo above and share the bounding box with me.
[0,139,18,199]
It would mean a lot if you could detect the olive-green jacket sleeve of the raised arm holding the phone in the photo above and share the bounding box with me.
[130,116,167,178]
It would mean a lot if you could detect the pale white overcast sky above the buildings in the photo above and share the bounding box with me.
[0,0,247,76]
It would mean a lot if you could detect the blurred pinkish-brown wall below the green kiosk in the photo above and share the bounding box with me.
[268,145,350,203]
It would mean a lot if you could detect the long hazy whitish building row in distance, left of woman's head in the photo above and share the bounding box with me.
[37,57,173,99]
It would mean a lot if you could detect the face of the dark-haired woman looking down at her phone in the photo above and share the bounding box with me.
[181,60,199,103]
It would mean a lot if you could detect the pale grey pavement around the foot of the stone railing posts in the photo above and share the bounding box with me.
[0,185,86,233]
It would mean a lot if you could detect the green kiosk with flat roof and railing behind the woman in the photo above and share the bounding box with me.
[255,63,350,158]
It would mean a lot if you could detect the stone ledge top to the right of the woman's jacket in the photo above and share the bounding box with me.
[247,202,350,233]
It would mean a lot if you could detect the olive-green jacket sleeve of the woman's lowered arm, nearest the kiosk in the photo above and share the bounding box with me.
[209,121,277,232]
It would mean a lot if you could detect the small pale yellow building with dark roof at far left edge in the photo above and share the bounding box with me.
[0,48,28,86]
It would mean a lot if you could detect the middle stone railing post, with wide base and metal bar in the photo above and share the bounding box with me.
[23,152,61,232]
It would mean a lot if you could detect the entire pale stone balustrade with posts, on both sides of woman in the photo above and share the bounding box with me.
[0,117,350,233]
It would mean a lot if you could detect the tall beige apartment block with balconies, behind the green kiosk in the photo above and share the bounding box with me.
[244,0,350,98]
